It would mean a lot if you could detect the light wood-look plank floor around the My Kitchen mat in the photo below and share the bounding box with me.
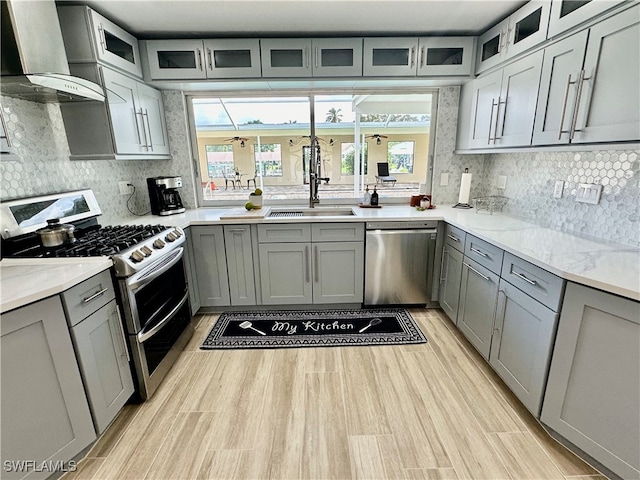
[63,309,606,480]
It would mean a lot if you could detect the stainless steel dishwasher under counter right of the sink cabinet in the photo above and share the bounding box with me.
[364,220,438,305]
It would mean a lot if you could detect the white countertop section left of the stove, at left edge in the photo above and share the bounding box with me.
[0,257,113,313]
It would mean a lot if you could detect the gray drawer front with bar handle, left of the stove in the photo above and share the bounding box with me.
[61,270,116,327]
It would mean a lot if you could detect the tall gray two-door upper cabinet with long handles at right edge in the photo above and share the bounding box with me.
[533,2,640,145]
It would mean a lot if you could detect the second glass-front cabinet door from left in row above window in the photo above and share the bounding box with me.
[204,38,261,78]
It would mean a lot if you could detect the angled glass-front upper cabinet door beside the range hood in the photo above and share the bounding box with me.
[89,10,142,78]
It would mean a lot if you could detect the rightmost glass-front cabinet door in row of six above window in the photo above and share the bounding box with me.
[418,37,474,76]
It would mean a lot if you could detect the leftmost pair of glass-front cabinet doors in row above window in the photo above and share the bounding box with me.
[140,39,261,80]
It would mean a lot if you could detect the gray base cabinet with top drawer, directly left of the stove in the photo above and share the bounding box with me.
[61,270,134,435]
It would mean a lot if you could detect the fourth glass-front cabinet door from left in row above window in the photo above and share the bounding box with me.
[311,38,362,77]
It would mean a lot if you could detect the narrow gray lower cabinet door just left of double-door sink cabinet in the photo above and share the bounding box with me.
[223,225,256,305]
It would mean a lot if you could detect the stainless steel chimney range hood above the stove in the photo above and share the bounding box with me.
[0,0,104,103]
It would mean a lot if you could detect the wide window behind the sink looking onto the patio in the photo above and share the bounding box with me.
[188,91,437,206]
